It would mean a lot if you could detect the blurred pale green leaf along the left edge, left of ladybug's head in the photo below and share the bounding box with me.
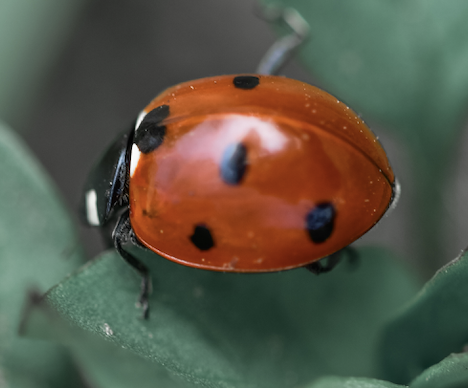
[0,124,85,388]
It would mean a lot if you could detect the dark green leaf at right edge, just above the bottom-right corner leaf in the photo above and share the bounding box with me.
[380,253,468,383]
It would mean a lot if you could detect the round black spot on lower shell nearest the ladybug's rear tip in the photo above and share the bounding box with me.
[306,202,336,243]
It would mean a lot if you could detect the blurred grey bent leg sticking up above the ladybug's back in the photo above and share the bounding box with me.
[256,5,310,74]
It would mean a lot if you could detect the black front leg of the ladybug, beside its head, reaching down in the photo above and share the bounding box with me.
[112,210,151,319]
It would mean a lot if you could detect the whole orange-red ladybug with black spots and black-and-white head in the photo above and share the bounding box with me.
[83,74,398,316]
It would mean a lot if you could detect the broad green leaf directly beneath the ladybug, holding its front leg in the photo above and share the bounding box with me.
[36,248,415,388]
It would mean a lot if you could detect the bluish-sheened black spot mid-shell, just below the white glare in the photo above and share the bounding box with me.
[219,143,247,185]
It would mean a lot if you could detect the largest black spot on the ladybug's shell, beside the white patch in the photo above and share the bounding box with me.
[133,105,169,154]
